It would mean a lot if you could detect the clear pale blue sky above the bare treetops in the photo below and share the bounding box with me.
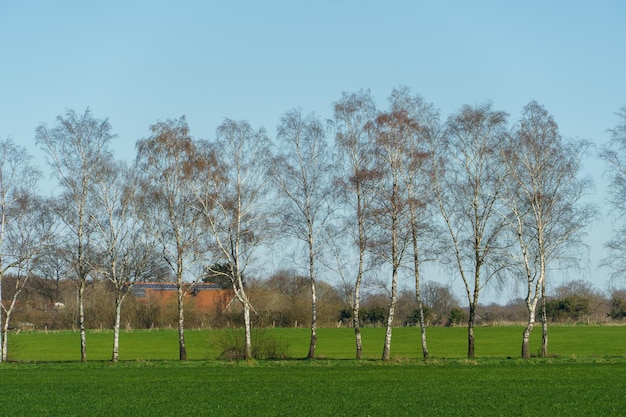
[0,0,626,295]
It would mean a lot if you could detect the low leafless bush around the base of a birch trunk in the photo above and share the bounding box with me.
[216,329,289,361]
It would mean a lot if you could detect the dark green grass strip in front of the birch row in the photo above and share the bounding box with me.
[0,359,626,416]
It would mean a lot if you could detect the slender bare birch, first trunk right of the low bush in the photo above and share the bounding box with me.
[271,109,334,359]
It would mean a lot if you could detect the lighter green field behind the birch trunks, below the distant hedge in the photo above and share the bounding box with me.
[4,326,626,362]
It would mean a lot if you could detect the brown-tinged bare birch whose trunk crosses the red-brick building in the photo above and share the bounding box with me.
[137,116,202,361]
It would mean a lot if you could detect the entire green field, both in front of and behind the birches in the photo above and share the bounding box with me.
[0,326,626,416]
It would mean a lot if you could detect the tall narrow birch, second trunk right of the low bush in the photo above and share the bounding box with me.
[334,91,376,359]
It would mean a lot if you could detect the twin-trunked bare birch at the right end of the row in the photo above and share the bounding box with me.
[503,101,594,358]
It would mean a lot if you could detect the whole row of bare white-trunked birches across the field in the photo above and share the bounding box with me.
[0,87,626,361]
